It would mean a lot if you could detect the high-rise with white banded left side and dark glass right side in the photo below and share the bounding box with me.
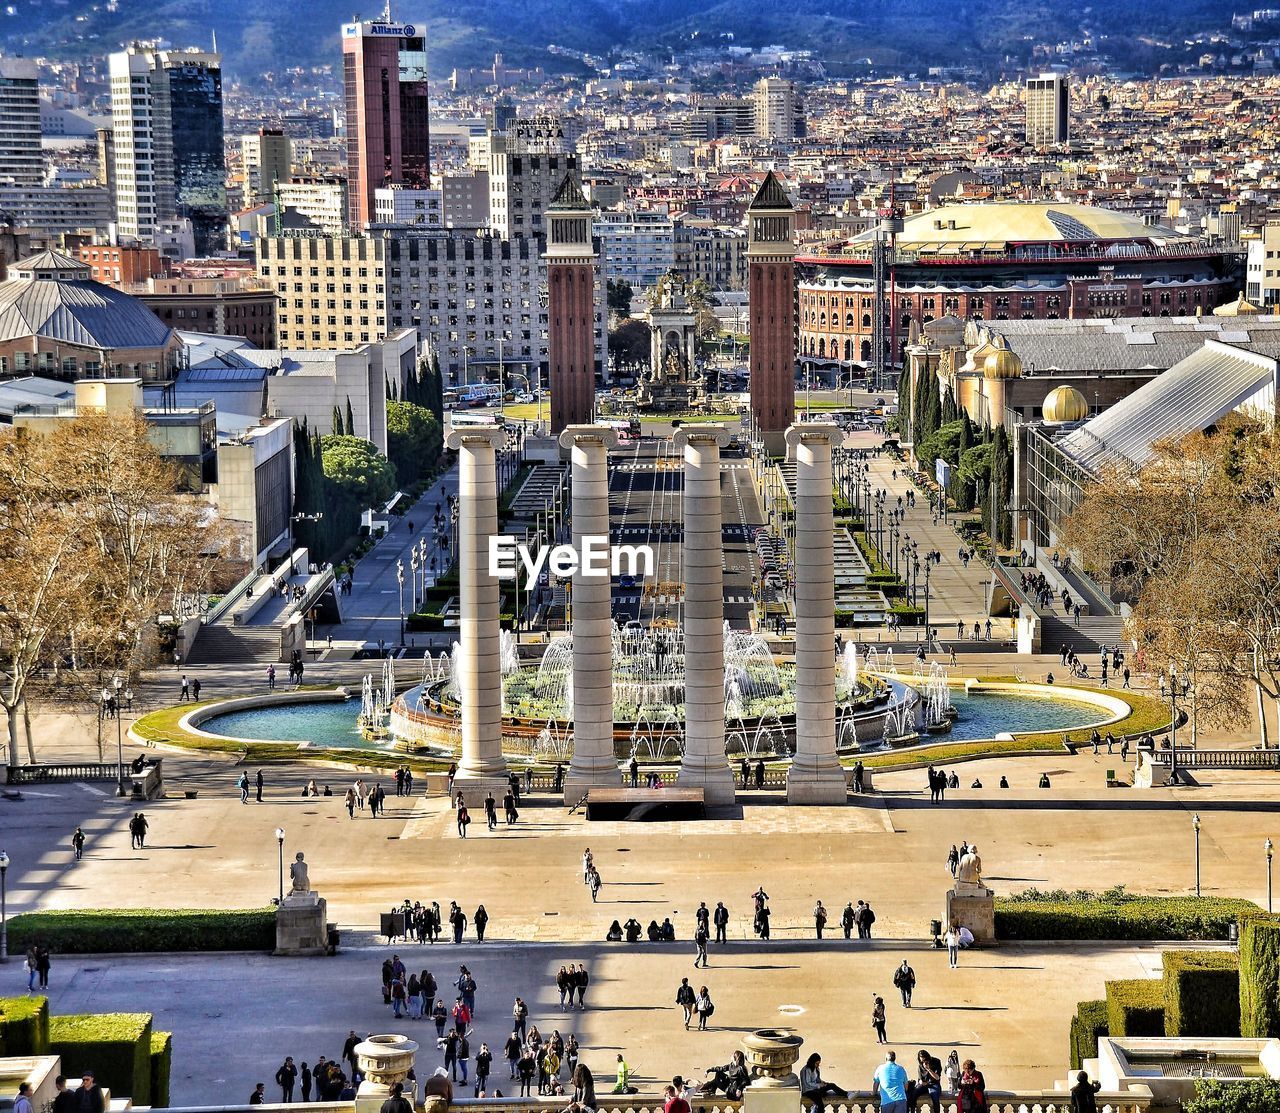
[109,43,227,255]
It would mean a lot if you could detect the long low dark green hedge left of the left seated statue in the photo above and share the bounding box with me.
[9,908,275,954]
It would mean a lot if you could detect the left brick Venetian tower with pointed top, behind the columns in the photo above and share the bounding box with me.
[547,173,598,436]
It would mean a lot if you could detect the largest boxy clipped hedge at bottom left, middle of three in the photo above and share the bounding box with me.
[49,1012,151,1105]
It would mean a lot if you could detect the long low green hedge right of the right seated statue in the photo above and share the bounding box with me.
[996,888,1258,940]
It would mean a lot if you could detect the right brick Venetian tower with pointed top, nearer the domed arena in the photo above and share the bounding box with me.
[746,170,796,455]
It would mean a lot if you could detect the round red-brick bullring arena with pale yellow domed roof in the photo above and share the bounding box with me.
[796,201,1243,368]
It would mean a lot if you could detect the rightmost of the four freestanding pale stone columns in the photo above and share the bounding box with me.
[786,423,846,803]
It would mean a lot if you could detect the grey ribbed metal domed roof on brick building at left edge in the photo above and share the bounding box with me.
[0,252,173,349]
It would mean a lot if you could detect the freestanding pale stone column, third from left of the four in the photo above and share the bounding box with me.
[675,425,736,806]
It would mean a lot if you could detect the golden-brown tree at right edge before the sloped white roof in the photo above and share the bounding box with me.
[1065,420,1280,743]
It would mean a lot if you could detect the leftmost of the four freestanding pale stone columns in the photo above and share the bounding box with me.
[448,426,507,798]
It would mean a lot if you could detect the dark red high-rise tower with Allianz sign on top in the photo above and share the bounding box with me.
[342,17,431,229]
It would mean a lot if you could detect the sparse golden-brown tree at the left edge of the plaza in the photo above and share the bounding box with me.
[0,413,217,764]
